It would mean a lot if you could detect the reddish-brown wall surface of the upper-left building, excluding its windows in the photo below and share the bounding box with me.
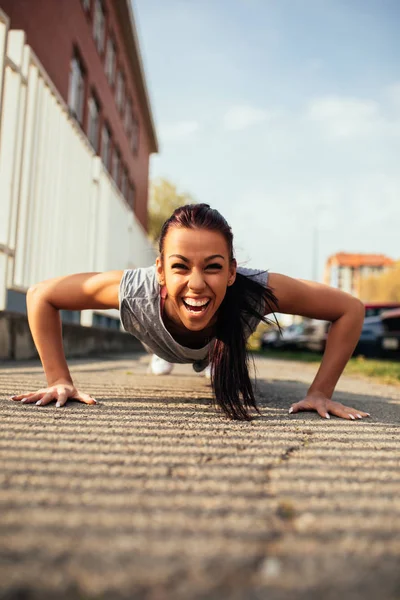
[0,0,151,229]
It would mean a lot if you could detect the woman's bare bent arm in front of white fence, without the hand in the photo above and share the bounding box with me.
[26,271,123,386]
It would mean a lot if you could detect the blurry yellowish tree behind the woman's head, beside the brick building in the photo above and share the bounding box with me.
[148,178,196,241]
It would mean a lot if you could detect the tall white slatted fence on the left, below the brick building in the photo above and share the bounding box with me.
[0,27,156,318]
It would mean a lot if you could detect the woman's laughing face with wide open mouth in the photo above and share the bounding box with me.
[156,227,236,331]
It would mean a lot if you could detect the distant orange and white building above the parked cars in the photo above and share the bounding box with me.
[324,252,395,298]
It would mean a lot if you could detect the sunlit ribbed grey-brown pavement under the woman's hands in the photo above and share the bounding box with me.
[0,354,400,600]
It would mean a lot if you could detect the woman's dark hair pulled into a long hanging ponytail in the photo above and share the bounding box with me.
[159,204,279,421]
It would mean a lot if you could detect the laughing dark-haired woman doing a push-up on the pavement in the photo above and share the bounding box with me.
[12,204,369,420]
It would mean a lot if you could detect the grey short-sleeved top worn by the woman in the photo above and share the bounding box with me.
[119,265,268,370]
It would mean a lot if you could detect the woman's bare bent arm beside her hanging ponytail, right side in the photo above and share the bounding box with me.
[268,273,366,418]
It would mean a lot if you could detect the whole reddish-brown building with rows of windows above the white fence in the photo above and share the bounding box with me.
[0,0,158,229]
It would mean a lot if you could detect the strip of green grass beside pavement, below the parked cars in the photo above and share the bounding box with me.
[253,350,400,385]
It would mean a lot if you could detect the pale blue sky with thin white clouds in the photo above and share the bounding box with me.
[133,0,400,281]
